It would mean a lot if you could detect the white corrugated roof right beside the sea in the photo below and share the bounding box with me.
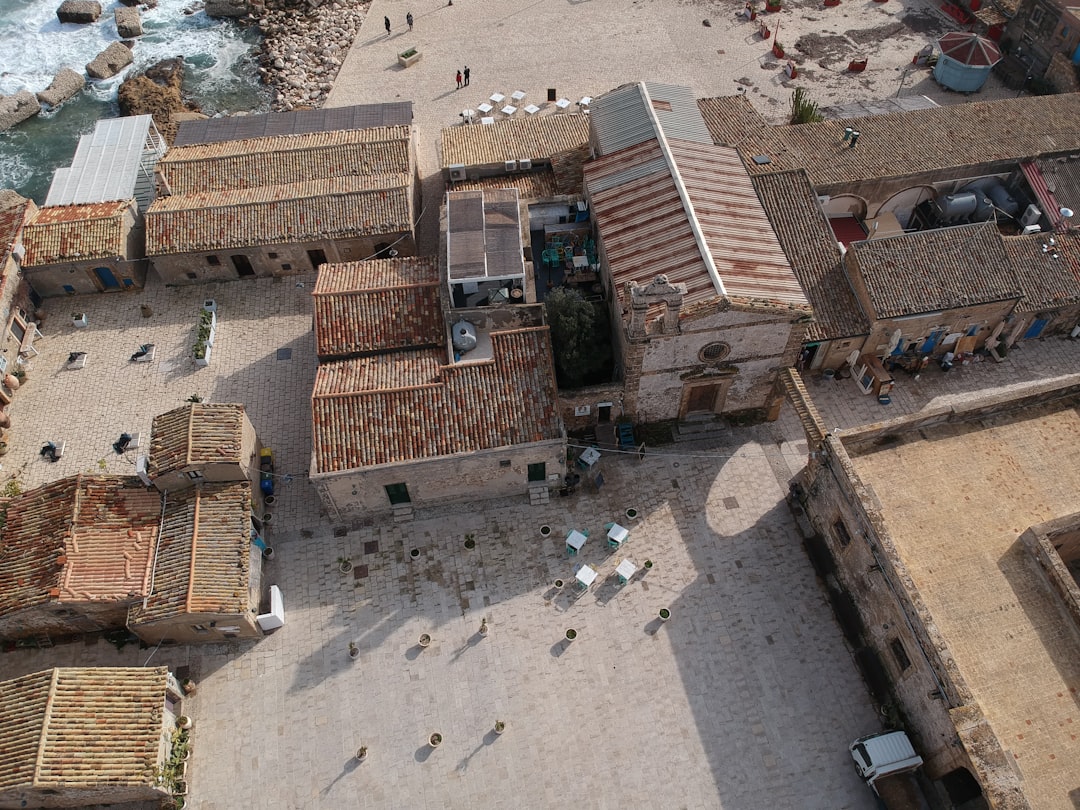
[45,116,165,205]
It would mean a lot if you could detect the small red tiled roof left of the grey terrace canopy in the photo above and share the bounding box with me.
[312,257,446,359]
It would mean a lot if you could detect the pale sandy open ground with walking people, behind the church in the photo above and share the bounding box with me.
[325,0,1014,253]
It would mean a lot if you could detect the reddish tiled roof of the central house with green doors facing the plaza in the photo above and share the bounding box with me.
[311,326,563,473]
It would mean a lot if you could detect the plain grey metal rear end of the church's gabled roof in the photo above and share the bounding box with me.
[591,82,713,156]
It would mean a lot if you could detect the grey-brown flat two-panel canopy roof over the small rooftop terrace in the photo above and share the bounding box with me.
[446,189,525,282]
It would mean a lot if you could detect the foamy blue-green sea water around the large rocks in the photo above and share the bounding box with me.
[0,0,270,204]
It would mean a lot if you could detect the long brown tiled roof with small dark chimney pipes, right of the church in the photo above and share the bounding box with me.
[734,93,1080,188]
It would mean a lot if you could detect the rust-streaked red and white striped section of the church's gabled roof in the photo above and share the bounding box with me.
[585,139,807,307]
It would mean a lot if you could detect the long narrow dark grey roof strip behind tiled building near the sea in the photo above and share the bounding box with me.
[173,102,413,146]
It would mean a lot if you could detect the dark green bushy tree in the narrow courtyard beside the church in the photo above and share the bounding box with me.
[544,287,610,388]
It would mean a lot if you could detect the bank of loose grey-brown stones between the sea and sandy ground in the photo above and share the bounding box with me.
[253,0,369,110]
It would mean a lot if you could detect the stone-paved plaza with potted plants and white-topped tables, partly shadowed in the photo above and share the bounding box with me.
[6,276,1080,810]
